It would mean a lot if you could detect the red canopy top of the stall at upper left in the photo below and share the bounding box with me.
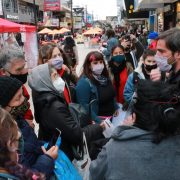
[0,18,36,33]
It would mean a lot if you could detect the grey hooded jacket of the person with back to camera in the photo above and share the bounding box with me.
[90,126,180,180]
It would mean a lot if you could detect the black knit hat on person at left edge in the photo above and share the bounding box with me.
[0,76,22,107]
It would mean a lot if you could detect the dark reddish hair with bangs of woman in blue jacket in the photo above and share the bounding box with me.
[81,51,109,80]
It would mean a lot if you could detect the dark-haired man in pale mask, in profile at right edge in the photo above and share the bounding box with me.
[155,28,180,84]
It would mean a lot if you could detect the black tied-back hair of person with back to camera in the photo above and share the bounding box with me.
[134,80,180,143]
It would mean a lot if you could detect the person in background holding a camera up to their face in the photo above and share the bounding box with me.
[120,34,144,69]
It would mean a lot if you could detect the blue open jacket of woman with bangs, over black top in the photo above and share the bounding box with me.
[76,76,118,123]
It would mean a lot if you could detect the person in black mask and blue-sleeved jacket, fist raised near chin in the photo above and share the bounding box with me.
[124,49,165,104]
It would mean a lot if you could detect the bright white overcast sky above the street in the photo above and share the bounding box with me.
[73,0,117,20]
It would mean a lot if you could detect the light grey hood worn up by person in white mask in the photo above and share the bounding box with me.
[28,63,60,95]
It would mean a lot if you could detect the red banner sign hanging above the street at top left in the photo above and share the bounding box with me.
[44,0,61,11]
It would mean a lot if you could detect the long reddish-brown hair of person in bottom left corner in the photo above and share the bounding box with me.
[0,108,45,180]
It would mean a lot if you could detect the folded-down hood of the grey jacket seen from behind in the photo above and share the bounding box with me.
[111,126,153,141]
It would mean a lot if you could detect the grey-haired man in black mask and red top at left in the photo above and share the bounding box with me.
[0,49,34,128]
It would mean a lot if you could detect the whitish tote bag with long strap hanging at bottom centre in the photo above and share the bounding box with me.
[72,132,91,180]
